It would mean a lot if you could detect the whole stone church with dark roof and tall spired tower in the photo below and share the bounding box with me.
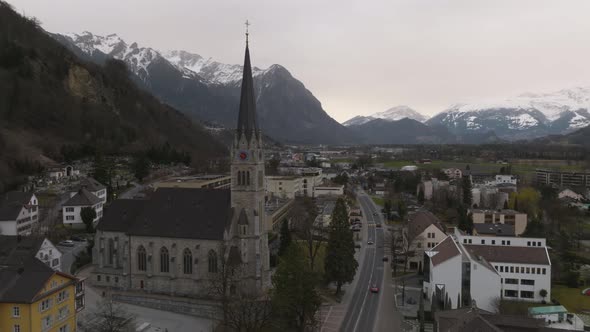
[91,34,270,296]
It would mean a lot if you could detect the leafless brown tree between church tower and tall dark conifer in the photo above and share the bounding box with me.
[291,197,327,271]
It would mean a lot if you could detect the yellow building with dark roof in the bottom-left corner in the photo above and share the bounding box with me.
[0,258,84,332]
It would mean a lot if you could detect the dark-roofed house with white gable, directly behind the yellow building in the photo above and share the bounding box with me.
[0,235,62,271]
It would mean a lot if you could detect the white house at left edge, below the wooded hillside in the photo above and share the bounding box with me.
[0,191,39,235]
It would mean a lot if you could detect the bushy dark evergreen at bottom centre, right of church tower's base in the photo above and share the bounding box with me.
[271,243,322,331]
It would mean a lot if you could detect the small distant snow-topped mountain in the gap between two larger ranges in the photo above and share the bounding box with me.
[349,118,457,144]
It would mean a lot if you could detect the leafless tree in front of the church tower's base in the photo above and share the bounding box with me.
[209,244,271,332]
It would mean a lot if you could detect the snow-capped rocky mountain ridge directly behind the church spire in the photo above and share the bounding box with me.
[54,32,356,144]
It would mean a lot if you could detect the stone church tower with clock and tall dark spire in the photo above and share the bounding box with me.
[231,26,270,290]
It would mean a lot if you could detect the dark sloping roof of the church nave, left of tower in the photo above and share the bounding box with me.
[97,188,232,240]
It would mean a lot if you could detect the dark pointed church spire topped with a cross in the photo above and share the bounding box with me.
[238,21,258,141]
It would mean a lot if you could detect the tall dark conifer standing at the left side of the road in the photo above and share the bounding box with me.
[324,198,358,294]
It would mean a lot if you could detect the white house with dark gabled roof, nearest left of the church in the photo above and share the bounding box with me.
[62,188,106,228]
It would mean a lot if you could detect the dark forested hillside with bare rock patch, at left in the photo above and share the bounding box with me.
[0,1,226,191]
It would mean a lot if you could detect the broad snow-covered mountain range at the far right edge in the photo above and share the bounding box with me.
[426,88,590,140]
